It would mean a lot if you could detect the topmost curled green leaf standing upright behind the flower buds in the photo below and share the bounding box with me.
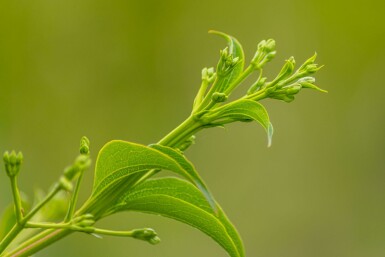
[209,30,245,93]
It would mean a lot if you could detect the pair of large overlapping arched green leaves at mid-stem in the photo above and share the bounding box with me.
[82,141,244,257]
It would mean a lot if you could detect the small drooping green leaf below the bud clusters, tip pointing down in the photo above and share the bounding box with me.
[203,99,273,146]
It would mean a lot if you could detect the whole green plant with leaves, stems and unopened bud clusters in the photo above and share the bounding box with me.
[0,31,325,257]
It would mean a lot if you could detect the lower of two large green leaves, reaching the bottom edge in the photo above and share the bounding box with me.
[110,178,245,257]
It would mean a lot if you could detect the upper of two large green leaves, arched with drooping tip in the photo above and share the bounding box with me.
[86,140,214,216]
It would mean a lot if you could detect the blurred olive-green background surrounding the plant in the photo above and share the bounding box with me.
[0,0,385,257]
